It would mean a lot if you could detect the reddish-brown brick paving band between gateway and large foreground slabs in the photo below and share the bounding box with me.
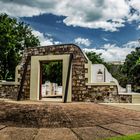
[0,102,140,128]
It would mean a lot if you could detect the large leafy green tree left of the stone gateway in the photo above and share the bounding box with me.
[0,14,39,80]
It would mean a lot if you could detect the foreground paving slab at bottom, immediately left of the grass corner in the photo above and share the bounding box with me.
[72,126,120,140]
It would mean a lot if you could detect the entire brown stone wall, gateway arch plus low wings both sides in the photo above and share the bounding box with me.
[0,44,132,102]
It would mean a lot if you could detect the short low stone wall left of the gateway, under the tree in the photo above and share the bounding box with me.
[0,82,19,100]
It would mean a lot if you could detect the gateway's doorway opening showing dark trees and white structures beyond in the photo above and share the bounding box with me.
[40,60,63,101]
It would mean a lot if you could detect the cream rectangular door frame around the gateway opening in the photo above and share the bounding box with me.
[30,54,72,103]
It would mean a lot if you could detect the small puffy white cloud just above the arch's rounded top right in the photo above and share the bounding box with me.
[74,37,91,47]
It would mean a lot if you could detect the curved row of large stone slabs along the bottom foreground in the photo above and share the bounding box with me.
[0,120,140,140]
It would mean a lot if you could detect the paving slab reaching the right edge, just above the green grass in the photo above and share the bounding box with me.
[103,123,140,135]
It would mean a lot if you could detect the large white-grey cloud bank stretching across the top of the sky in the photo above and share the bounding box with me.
[0,0,140,32]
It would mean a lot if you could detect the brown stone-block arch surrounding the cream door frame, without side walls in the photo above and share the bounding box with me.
[18,44,88,101]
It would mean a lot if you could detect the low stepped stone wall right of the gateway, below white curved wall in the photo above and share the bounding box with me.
[85,85,132,103]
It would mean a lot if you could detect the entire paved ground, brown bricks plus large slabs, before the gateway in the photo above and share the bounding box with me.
[0,101,140,140]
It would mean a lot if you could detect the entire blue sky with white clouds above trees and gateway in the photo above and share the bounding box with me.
[0,0,140,61]
